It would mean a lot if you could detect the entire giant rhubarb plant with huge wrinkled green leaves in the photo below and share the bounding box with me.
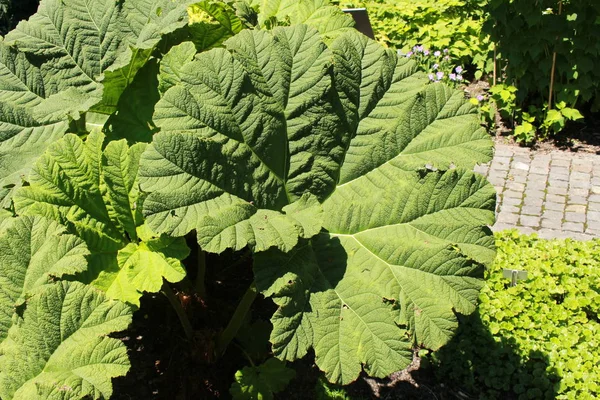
[0,0,495,399]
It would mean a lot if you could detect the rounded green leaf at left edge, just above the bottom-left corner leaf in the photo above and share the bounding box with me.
[0,217,89,341]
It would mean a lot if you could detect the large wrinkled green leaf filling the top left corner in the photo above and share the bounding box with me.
[0,0,188,207]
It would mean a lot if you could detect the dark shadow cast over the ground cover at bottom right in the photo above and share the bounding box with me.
[381,312,560,400]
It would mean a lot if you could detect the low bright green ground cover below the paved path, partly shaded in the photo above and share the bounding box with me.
[433,231,600,399]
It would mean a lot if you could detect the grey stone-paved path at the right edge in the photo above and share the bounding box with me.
[475,144,600,240]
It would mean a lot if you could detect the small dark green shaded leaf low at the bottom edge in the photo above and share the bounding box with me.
[229,358,296,400]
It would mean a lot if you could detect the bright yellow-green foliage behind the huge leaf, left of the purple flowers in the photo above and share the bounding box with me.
[340,0,493,78]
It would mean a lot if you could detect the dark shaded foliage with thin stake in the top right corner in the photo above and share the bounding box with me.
[485,0,600,107]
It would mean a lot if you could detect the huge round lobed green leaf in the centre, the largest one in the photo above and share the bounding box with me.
[140,25,495,383]
